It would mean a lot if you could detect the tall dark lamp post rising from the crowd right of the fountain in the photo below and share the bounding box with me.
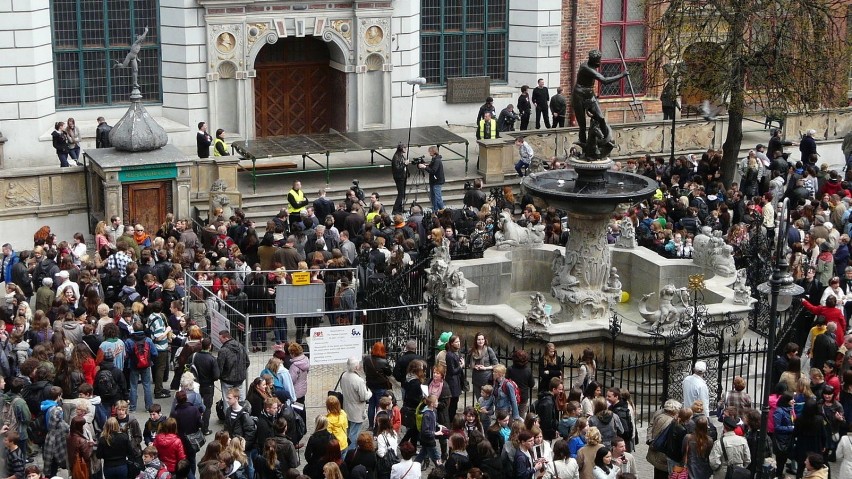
[756,199,804,479]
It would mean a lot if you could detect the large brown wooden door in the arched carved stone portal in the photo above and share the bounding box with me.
[254,38,346,138]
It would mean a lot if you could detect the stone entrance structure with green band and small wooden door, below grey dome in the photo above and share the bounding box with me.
[84,145,192,231]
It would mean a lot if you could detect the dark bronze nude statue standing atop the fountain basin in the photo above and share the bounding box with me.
[571,50,628,161]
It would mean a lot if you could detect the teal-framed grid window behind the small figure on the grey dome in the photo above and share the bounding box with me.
[50,0,162,109]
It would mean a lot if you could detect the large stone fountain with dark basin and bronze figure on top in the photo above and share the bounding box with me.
[429,52,753,353]
